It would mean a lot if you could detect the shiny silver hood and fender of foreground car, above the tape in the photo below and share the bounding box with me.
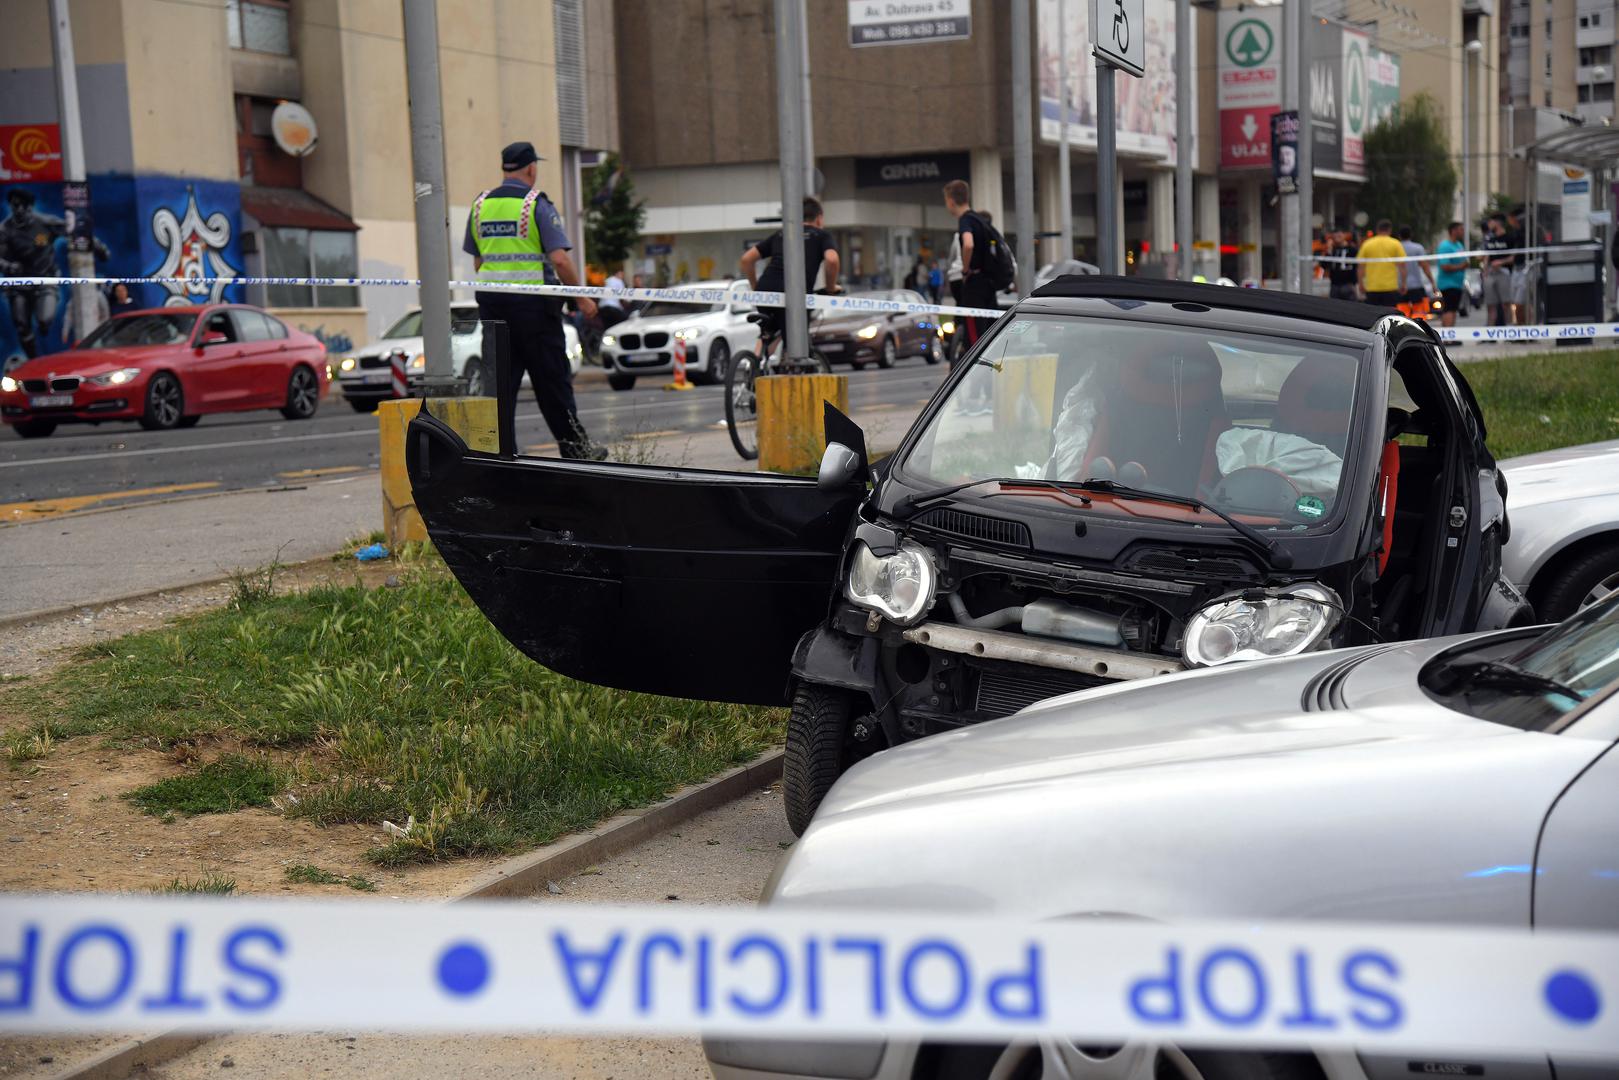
[772,641,1601,925]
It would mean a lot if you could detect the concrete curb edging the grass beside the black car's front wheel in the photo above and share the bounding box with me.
[49,750,785,1080]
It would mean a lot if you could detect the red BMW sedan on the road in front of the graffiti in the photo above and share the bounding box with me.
[0,304,330,439]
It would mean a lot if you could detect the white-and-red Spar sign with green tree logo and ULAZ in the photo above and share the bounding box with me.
[1217,8,1282,168]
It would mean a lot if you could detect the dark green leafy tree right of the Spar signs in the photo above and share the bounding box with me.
[1357,94,1459,244]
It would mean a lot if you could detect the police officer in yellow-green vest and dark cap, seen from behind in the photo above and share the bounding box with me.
[461,142,607,461]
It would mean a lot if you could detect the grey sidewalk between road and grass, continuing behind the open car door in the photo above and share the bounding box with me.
[0,399,916,620]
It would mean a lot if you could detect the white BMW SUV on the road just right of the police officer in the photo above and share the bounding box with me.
[602,280,759,390]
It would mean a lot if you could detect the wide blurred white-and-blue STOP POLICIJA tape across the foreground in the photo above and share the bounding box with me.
[0,895,1619,1059]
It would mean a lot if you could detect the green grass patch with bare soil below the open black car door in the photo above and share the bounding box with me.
[5,563,782,865]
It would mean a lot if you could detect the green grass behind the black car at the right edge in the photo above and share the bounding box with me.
[1462,345,1619,458]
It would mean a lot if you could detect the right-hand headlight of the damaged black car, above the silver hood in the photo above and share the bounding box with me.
[1183,583,1344,667]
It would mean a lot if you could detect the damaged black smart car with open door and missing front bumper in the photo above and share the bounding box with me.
[408,277,1532,831]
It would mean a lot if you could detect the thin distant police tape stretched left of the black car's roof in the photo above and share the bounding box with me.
[0,277,1005,319]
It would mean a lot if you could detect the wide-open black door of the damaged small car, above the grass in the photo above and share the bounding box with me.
[406,411,861,704]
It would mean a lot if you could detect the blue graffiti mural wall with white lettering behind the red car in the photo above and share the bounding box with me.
[0,175,243,366]
